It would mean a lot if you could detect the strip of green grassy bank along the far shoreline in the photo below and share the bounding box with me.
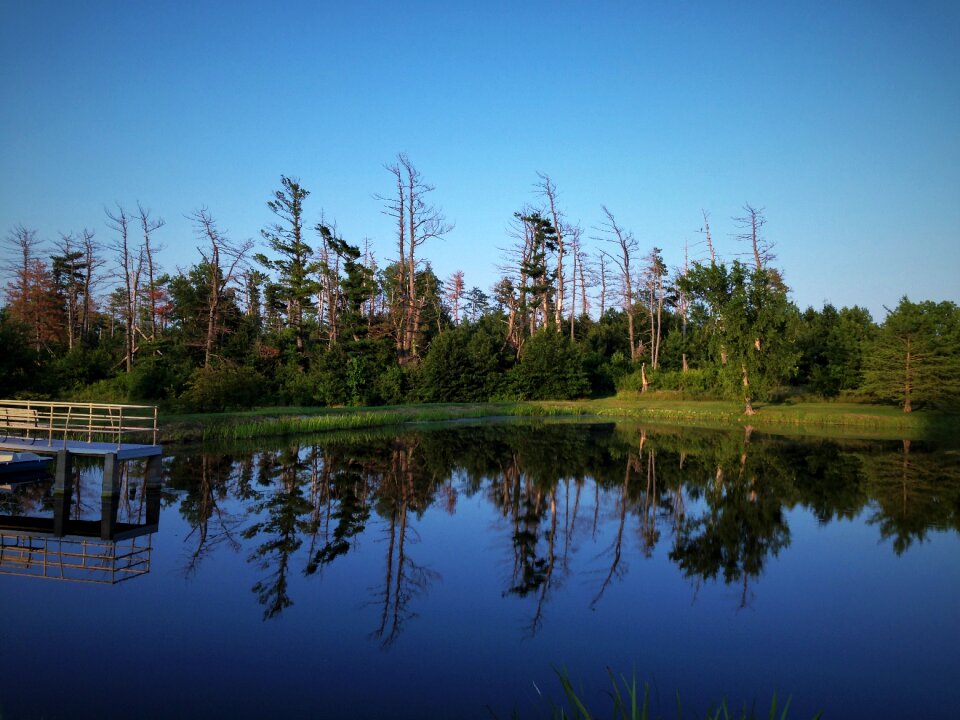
[161,398,960,442]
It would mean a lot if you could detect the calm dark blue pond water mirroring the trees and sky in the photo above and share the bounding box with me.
[0,422,960,720]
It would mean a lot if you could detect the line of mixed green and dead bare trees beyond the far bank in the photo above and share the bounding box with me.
[0,160,960,414]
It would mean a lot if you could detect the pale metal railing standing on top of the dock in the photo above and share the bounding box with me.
[0,400,157,447]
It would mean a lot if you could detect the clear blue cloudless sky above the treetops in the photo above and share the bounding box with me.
[0,0,960,319]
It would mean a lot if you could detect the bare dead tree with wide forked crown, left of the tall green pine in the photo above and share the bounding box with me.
[188,207,253,367]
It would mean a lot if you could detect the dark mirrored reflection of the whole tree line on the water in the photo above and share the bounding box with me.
[168,422,960,647]
